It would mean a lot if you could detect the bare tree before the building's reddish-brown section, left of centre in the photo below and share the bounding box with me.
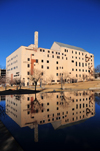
[29,69,44,91]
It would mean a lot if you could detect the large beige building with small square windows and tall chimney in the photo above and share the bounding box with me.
[6,31,94,86]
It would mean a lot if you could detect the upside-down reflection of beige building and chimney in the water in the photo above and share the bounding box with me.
[6,91,95,142]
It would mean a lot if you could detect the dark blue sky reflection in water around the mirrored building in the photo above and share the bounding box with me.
[0,91,100,150]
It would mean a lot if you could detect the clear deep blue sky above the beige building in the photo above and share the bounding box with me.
[0,0,100,67]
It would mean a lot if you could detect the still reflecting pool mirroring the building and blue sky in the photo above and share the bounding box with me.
[0,91,100,151]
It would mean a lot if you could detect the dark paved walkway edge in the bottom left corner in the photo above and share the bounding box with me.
[0,121,23,151]
